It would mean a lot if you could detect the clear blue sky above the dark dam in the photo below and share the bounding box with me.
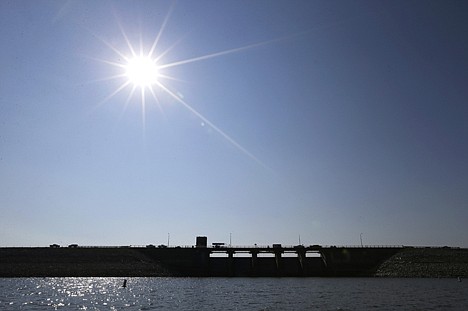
[0,0,468,247]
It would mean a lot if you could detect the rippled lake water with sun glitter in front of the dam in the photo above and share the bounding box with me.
[0,278,468,310]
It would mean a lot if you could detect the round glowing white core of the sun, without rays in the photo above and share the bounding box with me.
[124,56,160,89]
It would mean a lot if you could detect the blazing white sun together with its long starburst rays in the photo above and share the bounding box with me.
[91,7,270,168]
